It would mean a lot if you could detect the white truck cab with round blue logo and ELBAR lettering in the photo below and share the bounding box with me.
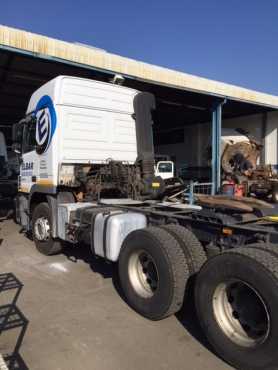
[13,76,138,193]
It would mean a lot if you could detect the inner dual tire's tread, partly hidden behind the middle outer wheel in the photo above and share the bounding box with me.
[162,224,207,276]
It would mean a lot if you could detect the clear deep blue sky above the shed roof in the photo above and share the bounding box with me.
[0,0,278,95]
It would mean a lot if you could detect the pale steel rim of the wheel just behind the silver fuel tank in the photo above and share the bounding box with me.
[128,250,159,298]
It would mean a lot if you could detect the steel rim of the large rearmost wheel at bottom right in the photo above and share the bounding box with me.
[213,280,270,347]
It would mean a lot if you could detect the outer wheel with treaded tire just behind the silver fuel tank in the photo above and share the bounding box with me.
[119,227,189,320]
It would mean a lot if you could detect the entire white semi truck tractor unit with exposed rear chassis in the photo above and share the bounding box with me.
[14,76,278,370]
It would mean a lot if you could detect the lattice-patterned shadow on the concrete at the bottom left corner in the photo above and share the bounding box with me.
[0,273,28,370]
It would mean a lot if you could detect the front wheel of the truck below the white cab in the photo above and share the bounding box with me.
[32,202,63,256]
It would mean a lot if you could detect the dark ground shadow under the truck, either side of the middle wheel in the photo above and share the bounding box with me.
[63,245,215,354]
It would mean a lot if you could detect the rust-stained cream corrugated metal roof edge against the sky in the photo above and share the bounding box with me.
[0,25,278,108]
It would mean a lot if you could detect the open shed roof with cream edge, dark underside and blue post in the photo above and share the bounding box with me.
[0,26,278,194]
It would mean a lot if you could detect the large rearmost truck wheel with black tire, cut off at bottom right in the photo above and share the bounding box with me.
[195,247,278,370]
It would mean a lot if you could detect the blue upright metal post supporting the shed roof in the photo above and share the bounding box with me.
[211,102,224,195]
